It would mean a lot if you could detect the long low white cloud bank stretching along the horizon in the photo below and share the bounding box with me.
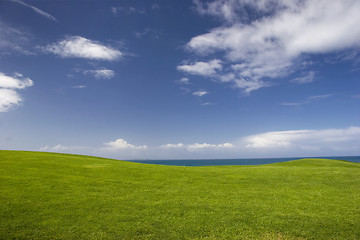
[40,126,360,159]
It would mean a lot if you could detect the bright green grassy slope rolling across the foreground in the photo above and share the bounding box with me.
[0,151,360,239]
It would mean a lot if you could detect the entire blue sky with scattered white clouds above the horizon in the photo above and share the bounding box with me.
[0,0,360,159]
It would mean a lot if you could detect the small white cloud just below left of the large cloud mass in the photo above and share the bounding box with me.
[177,59,222,76]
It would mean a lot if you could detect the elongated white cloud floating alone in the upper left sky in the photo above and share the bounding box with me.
[43,36,123,61]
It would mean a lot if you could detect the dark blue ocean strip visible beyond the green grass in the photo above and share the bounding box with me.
[130,156,360,166]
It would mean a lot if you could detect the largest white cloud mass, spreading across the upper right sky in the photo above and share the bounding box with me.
[178,0,360,93]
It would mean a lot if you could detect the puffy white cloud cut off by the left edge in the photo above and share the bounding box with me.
[0,72,34,112]
